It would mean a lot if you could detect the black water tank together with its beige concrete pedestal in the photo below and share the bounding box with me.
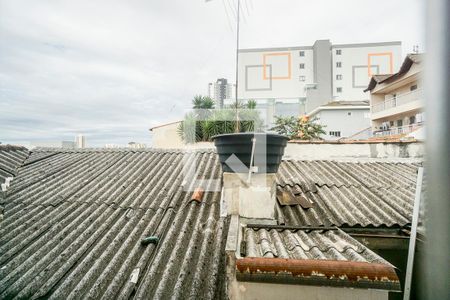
[214,133,287,223]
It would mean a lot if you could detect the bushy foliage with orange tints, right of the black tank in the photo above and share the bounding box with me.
[271,116,325,140]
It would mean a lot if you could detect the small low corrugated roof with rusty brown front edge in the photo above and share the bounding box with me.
[236,228,400,290]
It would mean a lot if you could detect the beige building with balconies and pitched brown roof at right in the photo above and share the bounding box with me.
[365,54,425,137]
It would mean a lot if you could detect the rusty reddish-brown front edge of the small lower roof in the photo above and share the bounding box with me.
[236,257,401,291]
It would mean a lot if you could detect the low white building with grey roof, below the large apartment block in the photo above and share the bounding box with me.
[308,101,370,140]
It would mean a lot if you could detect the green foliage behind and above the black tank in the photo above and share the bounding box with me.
[177,96,263,143]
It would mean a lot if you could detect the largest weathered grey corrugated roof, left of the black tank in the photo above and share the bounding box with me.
[0,149,227,299]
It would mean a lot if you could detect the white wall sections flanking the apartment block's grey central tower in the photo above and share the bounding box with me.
[238,43,402,103]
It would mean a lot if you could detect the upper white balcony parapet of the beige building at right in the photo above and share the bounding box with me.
[371,89,423,120]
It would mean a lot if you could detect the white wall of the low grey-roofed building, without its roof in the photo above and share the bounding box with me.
[315,107,370,140]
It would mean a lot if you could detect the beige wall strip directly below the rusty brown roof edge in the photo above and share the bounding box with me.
[230,281,389,300]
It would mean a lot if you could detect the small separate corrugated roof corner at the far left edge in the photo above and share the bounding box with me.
[0,145,28,183]
